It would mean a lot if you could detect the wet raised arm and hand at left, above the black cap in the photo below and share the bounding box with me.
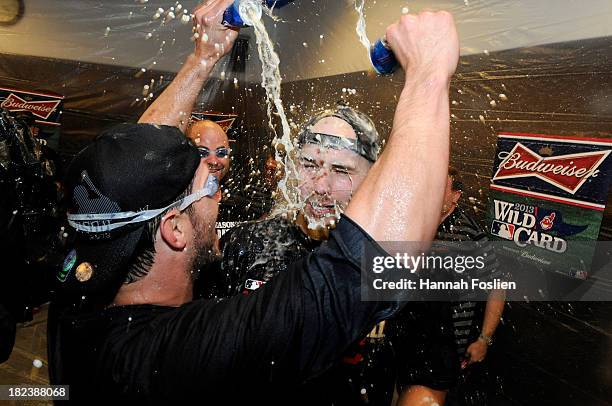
[138,0,238,132]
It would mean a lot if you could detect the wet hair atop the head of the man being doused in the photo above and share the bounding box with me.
[297,103,381,162]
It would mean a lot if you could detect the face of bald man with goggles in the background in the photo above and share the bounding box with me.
[187,120,230,181]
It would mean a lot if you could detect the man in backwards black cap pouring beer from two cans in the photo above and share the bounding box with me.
[49,0,459,404]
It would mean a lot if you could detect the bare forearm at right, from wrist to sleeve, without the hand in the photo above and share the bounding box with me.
[347,74,450,241]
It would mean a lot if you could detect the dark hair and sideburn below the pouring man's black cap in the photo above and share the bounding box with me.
[123,180,194,284]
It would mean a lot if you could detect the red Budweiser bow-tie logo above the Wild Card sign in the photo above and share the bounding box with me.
[493,142,612,194]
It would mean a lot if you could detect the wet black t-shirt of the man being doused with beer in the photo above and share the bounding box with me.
[215,216,393,405]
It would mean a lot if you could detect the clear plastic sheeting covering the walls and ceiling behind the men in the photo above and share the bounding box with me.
[0,0,612,225]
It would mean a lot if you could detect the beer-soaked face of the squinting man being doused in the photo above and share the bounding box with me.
[297,117,371,227]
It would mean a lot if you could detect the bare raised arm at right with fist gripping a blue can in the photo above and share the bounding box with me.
[346,12,459,241]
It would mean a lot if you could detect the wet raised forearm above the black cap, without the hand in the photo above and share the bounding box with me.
[138,54,216,132]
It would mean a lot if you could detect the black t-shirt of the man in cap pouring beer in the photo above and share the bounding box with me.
[49,218,399,404]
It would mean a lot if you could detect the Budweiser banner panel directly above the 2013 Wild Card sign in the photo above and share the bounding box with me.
[491,133,612,211]
